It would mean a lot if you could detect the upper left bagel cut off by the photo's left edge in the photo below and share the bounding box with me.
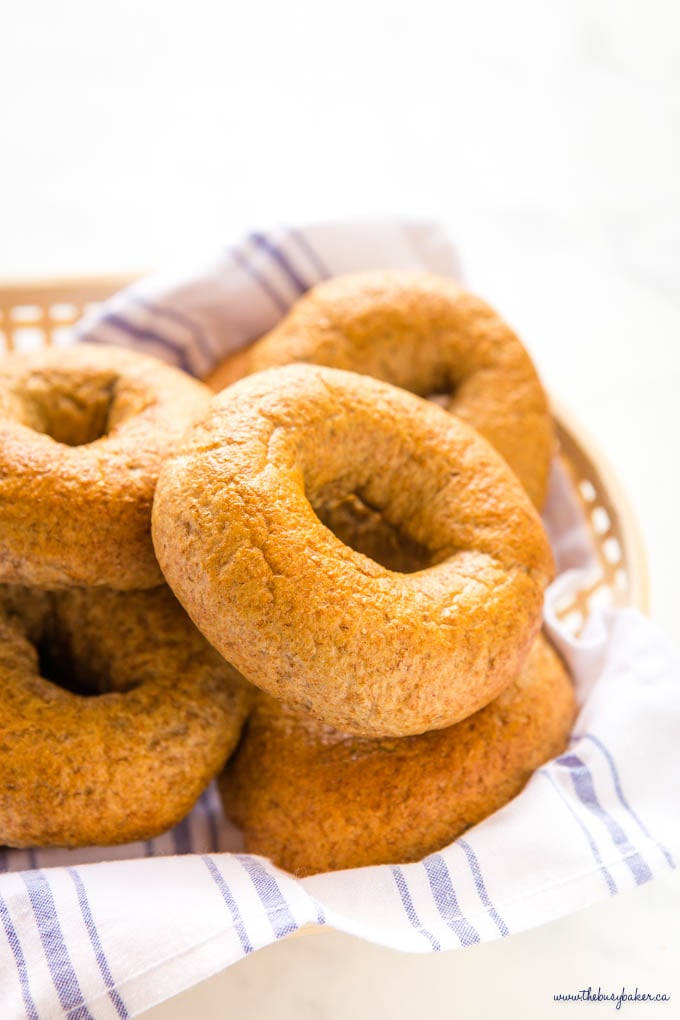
[0,344,210,591]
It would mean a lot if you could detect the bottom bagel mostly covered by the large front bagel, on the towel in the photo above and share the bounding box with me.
[219,636,576,875]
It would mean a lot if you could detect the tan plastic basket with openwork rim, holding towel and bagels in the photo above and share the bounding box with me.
[0,273,648,633]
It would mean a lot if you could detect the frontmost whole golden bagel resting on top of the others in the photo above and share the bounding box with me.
[153,365,553,736]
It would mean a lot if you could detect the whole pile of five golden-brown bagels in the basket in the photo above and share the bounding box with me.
[0,272,575,874]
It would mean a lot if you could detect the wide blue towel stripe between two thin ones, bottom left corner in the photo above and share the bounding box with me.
[21,871,93,1020]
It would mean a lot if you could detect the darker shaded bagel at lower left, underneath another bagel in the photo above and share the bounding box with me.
[0,585,252,847]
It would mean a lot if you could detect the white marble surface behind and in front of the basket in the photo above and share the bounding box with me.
[0,0,680,1020]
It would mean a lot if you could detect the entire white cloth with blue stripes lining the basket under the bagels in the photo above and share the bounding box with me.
[0,220,680,1020]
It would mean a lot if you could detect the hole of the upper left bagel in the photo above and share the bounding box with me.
[21,373,117,447]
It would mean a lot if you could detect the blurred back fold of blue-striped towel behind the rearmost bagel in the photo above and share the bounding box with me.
[75,220,460,377]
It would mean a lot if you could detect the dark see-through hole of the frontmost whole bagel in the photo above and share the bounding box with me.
[314,493,432,573]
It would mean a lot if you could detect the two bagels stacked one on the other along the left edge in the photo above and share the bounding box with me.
[0,345,252,847]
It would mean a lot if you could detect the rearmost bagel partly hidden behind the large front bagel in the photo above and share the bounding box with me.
[247,270,554,509]
